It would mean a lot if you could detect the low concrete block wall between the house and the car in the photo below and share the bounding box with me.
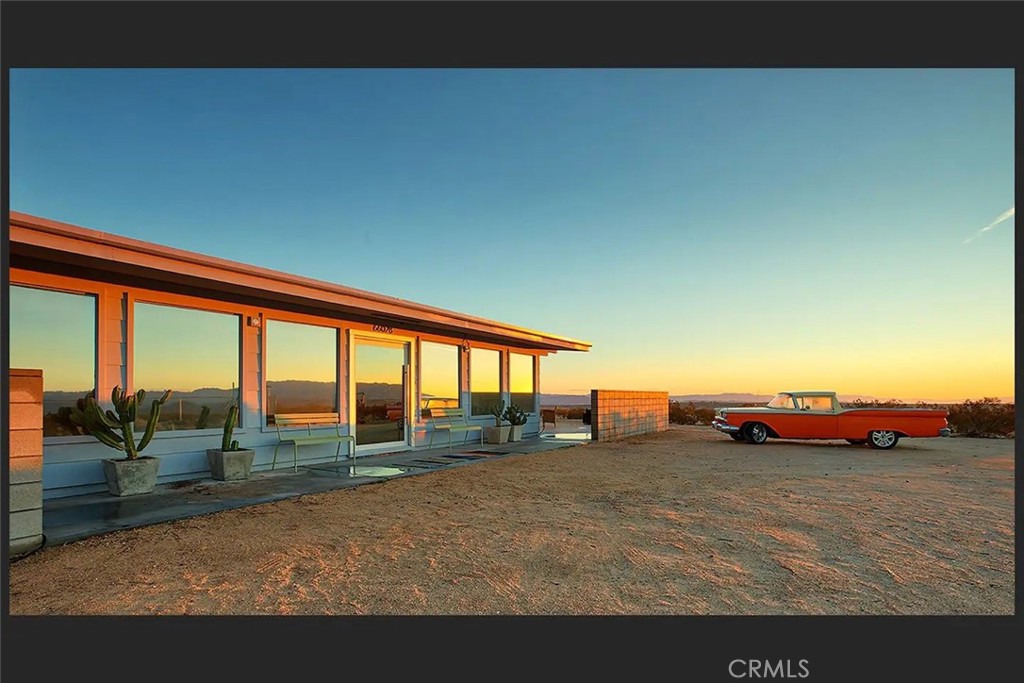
[590,389,669,441]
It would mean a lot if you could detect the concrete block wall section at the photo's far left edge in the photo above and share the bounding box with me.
[7,369,43,557]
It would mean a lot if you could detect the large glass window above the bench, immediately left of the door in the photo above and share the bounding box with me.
[265,321,338,424]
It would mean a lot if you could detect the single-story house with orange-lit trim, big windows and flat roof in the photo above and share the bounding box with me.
[8,211,591,498]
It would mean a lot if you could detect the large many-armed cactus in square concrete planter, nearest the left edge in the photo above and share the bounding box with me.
[70,386,171,496]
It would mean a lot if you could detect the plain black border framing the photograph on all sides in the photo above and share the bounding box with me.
[0,0,1024,681]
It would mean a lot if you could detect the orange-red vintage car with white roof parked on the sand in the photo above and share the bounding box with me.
[712,391,950,449]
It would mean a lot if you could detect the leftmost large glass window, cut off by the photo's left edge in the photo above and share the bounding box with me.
[5,286,96,436]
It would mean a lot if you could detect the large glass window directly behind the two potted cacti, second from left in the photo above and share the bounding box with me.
[132,303,242,431]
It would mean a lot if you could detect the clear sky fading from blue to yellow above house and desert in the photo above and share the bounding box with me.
[9,69,1016,400]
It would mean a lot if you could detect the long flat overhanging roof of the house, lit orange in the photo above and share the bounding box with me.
[8,211,591,351]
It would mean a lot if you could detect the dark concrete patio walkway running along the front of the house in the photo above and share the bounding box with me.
[43,422,590,547]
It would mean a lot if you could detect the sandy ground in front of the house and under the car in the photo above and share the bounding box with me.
[9,426,1014,614]
